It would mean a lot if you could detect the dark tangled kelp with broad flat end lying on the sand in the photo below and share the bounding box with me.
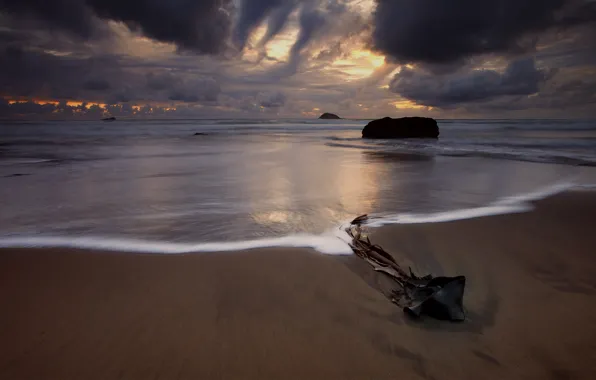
[346,215,466,321]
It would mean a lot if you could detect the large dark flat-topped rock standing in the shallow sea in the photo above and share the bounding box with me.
[362,117,439,139]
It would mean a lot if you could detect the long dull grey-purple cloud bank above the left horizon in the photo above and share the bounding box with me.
[0,47,221,104]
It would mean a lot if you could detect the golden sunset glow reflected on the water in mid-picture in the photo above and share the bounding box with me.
[245,139,387,230]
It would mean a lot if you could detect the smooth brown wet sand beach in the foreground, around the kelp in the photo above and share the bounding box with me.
[0,192,596,380]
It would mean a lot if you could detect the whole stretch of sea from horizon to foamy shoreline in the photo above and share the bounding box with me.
[0,120,596,253]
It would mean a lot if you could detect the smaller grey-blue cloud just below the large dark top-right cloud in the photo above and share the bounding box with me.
[389,59,554,108]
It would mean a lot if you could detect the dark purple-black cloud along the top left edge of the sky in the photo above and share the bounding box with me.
[0,0,231,54]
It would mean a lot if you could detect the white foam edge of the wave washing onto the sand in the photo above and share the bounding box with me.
[0,182,596,255]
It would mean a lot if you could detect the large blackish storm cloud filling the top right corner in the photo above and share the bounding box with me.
[373,0,596,63]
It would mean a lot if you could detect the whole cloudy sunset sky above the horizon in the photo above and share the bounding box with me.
[0,0,596,119]
